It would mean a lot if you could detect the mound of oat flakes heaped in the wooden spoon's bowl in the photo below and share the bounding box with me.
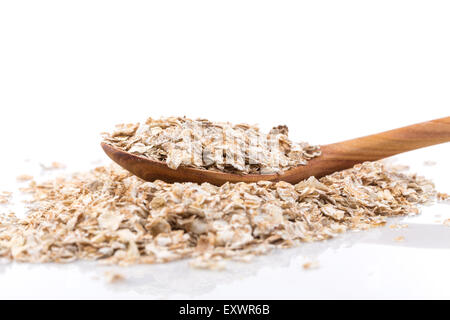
[104,117,320,174]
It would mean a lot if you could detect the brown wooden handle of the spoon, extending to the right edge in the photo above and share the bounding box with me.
[285,117,450,182]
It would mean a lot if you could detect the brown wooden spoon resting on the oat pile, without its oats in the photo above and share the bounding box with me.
[101,117,450,185]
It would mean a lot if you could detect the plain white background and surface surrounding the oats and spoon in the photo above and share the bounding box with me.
[0,0,450,298]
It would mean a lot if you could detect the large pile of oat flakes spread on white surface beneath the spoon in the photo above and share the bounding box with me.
[0,162,436,267]
